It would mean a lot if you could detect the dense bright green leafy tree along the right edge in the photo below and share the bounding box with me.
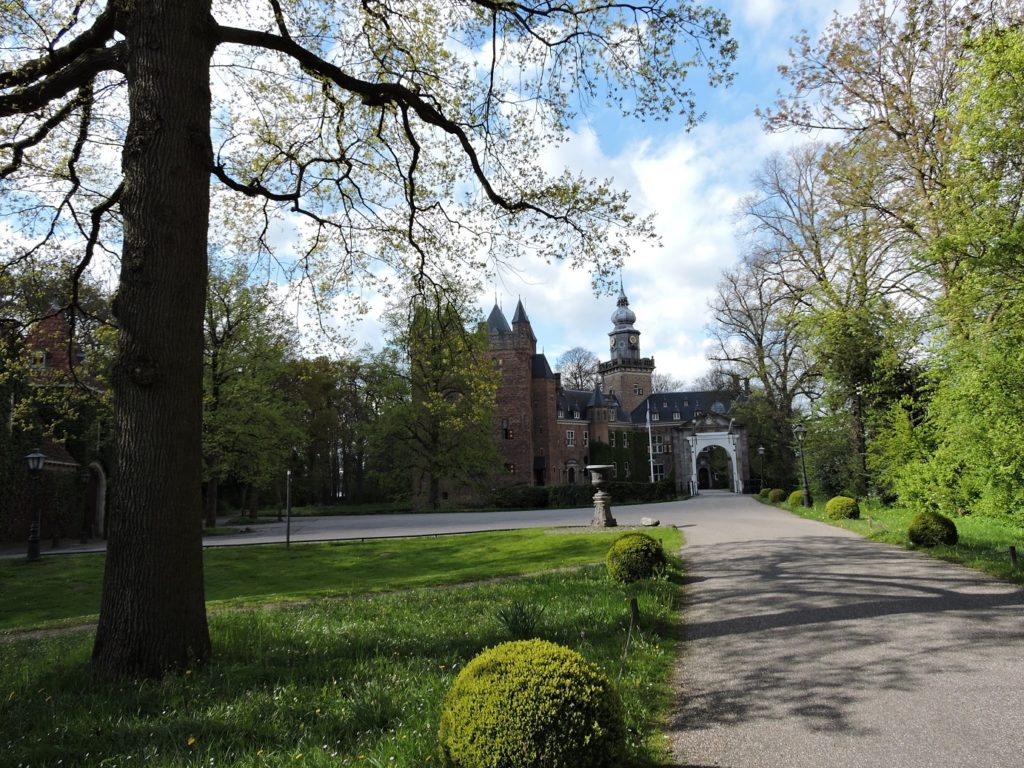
[888,27,1024,518]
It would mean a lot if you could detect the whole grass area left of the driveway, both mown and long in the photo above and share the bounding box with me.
[6,528,681,768]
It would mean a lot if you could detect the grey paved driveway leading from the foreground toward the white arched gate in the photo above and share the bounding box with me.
[670,496,1024,768]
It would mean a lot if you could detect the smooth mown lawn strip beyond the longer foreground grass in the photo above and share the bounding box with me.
[0,528,681,632]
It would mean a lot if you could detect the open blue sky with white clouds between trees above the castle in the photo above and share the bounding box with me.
[337,0,855,383]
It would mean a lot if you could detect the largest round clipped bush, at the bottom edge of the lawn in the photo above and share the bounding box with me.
[438,640,626,768]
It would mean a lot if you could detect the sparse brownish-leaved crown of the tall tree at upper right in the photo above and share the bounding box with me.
[761,0,1020,291]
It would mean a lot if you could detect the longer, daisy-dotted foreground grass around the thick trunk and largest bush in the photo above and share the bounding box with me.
[0,530,679,768]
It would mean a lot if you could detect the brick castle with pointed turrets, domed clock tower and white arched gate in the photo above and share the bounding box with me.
[487,288,750,494]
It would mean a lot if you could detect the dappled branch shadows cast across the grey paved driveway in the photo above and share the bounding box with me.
[670,536,1024,745]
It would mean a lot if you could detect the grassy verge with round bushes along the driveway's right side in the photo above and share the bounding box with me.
[782,503,1024,584]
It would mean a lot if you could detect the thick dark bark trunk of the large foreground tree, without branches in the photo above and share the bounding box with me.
[92,0,213,677]
